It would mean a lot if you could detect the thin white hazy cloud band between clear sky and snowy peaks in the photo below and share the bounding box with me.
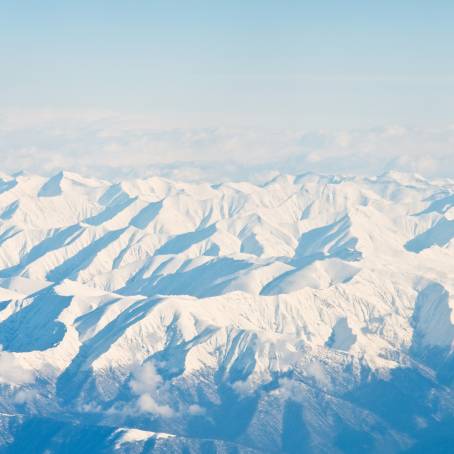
[0,112,454,181]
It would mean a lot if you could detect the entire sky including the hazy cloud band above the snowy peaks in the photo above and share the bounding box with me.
[0,0,454,180]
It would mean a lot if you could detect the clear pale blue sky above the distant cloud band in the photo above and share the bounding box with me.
[0,0,454,129]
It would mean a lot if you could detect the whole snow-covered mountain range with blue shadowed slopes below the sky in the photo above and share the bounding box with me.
[0,172,454,453]
